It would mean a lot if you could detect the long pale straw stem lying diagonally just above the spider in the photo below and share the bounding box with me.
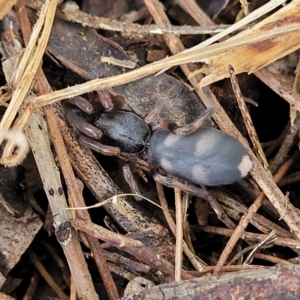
[29,25,300,111]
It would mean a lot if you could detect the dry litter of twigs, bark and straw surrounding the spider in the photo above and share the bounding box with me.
[0,0,300,299]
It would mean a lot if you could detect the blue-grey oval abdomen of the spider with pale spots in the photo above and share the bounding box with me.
[149,127,253,186]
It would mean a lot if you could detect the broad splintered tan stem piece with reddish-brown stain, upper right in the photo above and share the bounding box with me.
[200,0,300,86]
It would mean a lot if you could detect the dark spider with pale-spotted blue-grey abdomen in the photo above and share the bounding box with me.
[66,98,253,186]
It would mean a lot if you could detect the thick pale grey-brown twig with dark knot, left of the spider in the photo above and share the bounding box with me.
[18,1,97,299]
